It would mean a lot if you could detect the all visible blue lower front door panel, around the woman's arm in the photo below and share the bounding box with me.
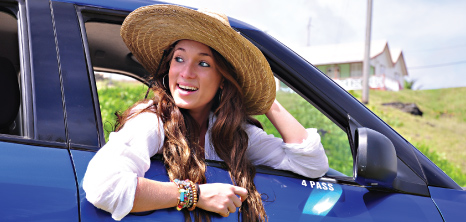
[71,150,442,221]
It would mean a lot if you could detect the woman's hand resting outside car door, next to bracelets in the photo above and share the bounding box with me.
[197,183,248,217]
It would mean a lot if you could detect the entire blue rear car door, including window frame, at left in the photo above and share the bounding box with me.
[0,0,79,221]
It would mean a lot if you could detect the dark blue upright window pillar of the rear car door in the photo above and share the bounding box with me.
[26,0,67,142]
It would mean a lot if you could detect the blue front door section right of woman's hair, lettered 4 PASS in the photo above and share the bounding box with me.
[255,174,442,221]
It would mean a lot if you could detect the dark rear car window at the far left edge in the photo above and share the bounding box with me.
[0,6,23,136]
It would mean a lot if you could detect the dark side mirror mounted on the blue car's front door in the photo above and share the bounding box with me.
[353,127,397,189]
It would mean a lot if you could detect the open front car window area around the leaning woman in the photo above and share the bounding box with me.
[85,13,353,176]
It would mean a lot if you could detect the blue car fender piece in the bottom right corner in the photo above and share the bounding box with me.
[429,187,466,221]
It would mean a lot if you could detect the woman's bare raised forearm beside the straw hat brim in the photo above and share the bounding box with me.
[265,100,308,143]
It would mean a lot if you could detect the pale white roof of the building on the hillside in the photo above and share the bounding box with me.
[296,40,394,65]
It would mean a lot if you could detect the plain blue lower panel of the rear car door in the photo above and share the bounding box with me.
[0,142,79,221]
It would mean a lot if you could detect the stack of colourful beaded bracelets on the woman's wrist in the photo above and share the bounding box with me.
[173,179,199,211]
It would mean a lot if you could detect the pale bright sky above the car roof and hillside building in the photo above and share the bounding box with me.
[166,0,466,90]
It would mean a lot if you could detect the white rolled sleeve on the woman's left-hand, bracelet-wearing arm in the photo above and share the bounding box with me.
[83,112,164,220]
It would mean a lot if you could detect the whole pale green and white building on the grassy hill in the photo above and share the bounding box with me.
[296,40,408,91]
